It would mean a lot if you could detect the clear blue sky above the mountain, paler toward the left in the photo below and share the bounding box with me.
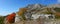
[0,0,60,16]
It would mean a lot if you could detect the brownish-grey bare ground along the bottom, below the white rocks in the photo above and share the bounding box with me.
[14,19,60,24]
